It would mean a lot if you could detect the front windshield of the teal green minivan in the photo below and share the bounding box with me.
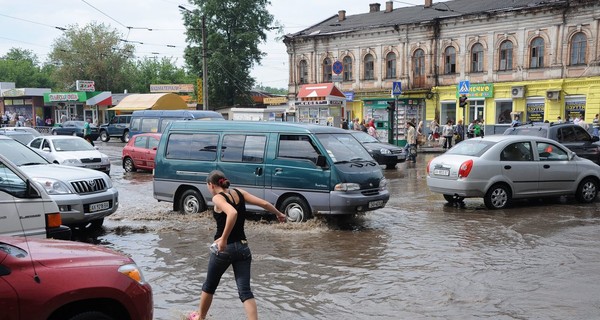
[317,133,373,163]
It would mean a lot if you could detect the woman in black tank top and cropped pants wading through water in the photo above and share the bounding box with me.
[189,170,286,320]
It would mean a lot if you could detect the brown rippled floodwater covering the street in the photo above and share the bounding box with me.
[92,143,600,320]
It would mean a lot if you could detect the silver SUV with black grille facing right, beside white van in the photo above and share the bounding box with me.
[0,135,119,228]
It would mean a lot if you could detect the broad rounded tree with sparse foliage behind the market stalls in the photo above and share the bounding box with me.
[49,22,134,92]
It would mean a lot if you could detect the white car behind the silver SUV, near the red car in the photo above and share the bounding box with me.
[27,136,110,175]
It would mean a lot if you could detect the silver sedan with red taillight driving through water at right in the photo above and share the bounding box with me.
[427,135,600,209]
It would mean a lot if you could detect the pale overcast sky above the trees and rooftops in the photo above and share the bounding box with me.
[0,0,424,88]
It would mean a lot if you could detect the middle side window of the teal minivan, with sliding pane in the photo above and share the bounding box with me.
[221,134,267,163]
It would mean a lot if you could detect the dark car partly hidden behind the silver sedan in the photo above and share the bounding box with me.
[504,123,600,164]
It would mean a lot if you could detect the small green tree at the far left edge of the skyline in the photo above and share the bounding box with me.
[0,48,53,88]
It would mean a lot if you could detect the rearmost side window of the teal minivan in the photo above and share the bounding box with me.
[166,133,219,161]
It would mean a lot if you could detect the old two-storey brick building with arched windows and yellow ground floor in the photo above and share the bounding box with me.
[284,0,600,140]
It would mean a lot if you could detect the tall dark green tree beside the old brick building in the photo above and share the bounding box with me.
[183,0,274,109]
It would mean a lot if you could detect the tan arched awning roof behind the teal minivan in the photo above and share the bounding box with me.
[108,93,188,111]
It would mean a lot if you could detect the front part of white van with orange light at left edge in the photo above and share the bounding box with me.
[0,155,71,240]
